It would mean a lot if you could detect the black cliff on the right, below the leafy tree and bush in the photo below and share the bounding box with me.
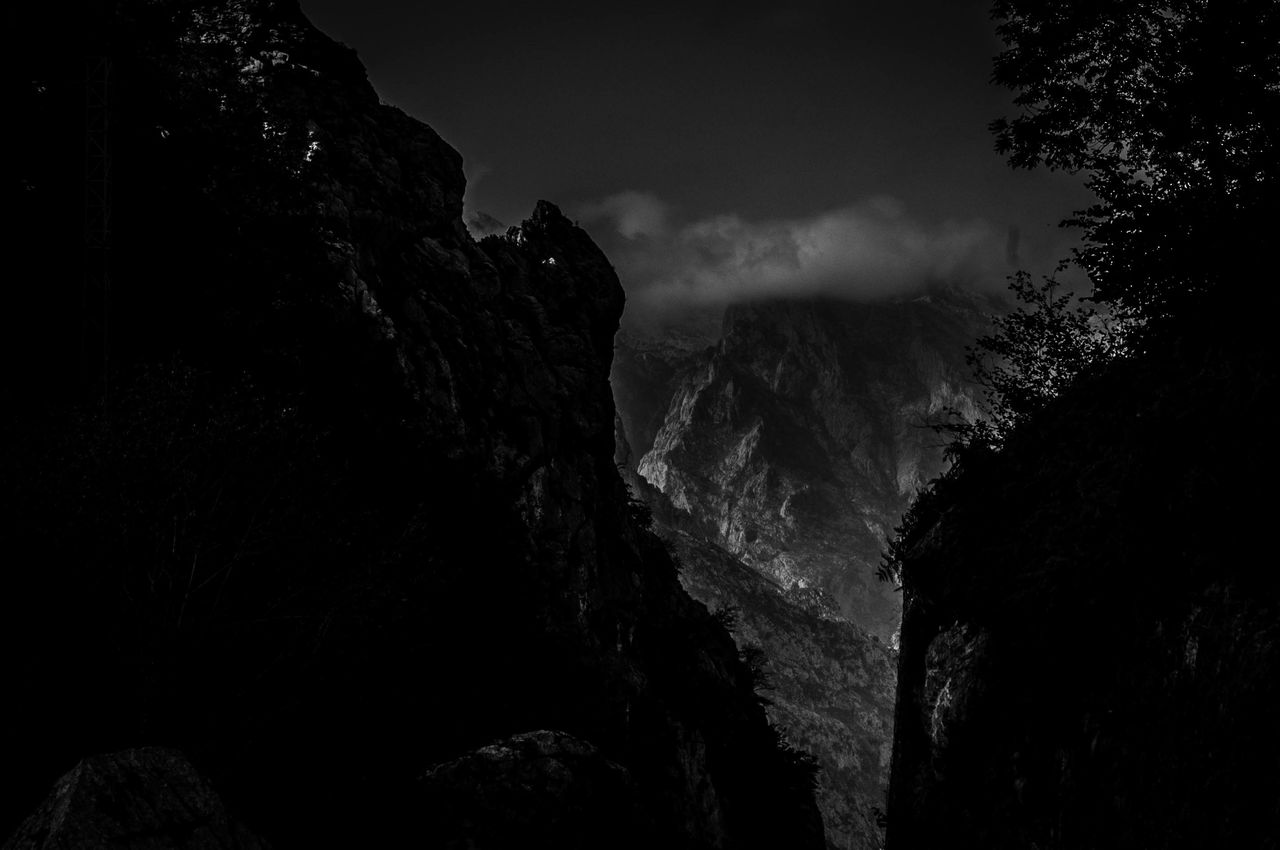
[888,320,1280,850]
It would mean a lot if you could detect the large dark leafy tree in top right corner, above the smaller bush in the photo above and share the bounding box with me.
[992,0,1280,320]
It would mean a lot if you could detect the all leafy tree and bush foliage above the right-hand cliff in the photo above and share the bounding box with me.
[942,0,1280,460]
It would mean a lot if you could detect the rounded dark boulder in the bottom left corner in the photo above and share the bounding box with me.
[4,748,268,850]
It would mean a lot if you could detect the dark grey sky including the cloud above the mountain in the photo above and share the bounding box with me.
[302,0,1088,312]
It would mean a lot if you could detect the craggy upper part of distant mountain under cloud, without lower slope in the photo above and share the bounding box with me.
[639,294,984,640]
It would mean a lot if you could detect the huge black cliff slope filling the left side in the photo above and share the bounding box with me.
[0,0,822,847]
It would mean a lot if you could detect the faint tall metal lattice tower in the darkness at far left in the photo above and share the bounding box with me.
[81,56,111,401]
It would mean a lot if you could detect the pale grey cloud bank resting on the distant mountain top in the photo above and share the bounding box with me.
[576,192,1010,309]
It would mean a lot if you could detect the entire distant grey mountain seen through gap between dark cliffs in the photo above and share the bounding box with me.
[612,291,997,849]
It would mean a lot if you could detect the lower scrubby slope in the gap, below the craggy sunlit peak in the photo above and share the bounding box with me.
[663,529,897,850]
